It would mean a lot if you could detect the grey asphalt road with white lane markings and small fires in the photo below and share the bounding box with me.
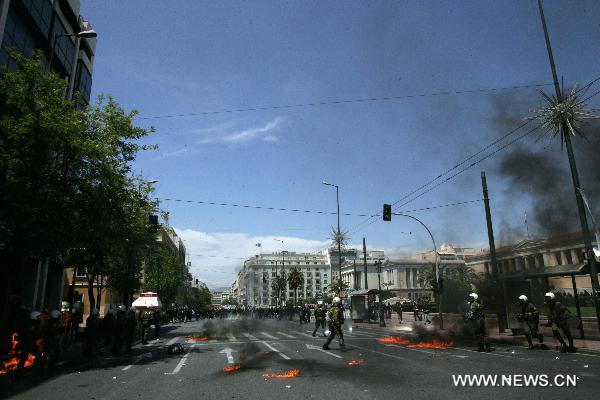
[0,320,600,400]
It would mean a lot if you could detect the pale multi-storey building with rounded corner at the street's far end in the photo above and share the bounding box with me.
[232,251,331,307]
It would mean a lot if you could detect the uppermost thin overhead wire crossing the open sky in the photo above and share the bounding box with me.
[137,83,552,120]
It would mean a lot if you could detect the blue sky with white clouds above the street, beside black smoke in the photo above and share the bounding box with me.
[81,0,600,287]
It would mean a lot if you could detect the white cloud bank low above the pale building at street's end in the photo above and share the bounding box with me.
[175,228,328,288]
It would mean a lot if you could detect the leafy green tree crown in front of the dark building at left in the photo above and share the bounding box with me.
[0,51,157,307]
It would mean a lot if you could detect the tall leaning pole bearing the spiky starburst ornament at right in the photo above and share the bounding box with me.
[538,0,600,328]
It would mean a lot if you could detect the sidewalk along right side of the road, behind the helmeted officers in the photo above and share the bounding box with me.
[353,312,600,353]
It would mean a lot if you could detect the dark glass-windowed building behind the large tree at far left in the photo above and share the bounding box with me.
[0,0,96,316]
